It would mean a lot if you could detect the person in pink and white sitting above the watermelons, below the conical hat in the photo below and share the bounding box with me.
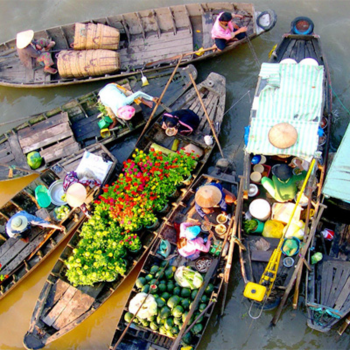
[176,222,213,260]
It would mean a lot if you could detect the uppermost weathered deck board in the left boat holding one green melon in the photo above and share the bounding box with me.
[22,123,73,153]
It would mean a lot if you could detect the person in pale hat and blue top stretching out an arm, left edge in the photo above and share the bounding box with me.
[6,210,65,242]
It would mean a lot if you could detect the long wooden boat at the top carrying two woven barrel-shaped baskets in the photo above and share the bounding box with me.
[0,2,276,88]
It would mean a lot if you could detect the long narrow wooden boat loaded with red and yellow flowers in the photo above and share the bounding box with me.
[24,73,226,349]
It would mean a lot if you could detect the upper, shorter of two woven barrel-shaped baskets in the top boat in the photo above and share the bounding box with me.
[71,23,120,50]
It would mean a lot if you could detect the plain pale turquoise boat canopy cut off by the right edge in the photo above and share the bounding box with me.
[322,126,350,202]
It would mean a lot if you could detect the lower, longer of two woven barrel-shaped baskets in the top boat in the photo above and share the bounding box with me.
[57,50,120,78]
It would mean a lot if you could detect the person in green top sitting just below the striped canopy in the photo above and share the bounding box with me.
[261,164,306,202]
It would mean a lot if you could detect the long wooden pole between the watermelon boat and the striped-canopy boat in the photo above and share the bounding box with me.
[221,181,243,316]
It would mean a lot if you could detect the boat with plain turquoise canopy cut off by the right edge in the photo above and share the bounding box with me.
[305,121,350,332]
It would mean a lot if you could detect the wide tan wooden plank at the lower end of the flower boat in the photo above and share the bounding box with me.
[52,290,95,330]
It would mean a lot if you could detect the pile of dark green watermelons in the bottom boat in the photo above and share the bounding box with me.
[124,261,214,345]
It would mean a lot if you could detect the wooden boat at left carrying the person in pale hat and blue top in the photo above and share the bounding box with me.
[0,144,116,299]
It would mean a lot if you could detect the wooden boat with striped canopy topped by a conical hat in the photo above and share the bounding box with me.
[240,19,332,317]
